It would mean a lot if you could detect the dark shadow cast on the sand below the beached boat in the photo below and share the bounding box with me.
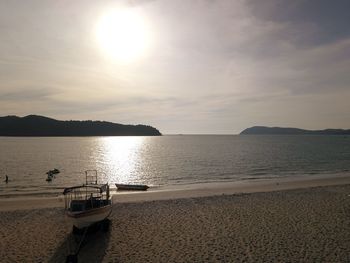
[48,222,111,263]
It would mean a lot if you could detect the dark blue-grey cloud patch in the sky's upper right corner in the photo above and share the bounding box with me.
[247,0,350,46]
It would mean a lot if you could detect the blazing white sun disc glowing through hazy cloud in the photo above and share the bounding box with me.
[96,9,150,61]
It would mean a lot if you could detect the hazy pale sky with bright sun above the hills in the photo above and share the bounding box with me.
[0,0,350,134]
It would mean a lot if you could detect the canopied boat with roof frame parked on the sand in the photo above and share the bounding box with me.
[63,170,112,229]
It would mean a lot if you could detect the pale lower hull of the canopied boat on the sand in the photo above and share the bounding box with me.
[66,204,112,229]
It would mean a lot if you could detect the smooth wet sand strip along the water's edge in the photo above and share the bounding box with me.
[0,174,350,211]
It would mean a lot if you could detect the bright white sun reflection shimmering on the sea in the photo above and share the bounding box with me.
[99,137,145,183]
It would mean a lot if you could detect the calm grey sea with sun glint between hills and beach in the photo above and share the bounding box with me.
[0,135,350,197]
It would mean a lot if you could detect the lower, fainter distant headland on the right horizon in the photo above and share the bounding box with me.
[240,126,350,135]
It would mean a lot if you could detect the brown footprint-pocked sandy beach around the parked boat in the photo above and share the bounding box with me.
[0,177,350,262]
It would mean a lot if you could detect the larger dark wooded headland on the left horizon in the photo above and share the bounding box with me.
[0,115,161,136]
